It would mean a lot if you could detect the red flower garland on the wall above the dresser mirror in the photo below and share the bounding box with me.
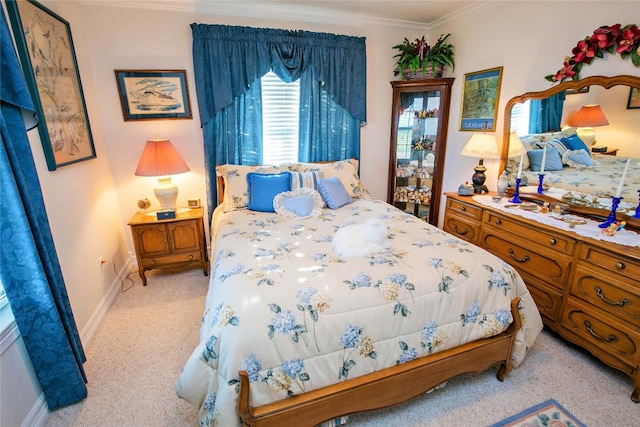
[545,24,640,82]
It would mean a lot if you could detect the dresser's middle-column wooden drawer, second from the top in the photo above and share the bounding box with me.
[480,228,571,289]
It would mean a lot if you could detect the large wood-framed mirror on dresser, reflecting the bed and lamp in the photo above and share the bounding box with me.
[500,75,640,229]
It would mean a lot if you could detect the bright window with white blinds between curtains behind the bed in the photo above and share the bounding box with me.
[261,71,300,165]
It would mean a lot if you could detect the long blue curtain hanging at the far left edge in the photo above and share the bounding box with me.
[0,6,87,410]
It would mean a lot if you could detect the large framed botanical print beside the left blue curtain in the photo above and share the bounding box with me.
[6,0,96,171]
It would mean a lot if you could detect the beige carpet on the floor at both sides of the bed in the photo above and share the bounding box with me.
[45,269,640,427]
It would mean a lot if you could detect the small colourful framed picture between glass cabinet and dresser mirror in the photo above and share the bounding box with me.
[460,67,502,132]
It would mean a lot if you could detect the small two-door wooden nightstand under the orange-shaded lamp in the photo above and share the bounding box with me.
[128,207,209,286]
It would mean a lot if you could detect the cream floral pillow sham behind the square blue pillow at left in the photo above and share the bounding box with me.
[216,164,286,212]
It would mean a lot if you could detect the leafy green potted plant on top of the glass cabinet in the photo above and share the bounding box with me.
[393,34,455,80]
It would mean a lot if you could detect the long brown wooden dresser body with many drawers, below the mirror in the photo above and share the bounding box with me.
[443,193,640,403]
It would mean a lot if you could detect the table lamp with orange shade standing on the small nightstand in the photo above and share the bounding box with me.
[135,138,190,211]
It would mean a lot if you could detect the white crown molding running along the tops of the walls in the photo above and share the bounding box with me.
[79,0,498,31]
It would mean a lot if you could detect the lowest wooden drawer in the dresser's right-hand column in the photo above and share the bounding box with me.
[561,298,640,366]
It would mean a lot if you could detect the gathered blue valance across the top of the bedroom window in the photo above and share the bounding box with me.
[191,24,366,126]
